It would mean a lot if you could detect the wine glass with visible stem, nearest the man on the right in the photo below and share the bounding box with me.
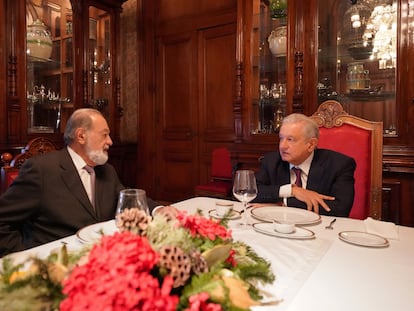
[233,170,257,226]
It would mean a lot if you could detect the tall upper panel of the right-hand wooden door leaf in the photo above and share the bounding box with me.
[199,24,236,142]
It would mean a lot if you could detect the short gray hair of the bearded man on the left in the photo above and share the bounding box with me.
[63,108,102,146]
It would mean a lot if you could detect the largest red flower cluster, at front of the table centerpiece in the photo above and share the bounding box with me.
[60,232,178,311]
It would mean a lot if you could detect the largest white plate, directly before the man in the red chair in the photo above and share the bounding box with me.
[251,205,321,225]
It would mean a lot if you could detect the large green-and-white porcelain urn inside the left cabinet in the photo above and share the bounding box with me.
[26,19,52,60]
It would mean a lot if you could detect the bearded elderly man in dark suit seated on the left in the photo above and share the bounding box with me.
[0,108,168,256]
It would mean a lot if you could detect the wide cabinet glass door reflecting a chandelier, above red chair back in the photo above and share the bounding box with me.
[317,0,399,136]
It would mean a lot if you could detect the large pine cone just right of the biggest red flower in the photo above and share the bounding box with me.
[160,246,191,288]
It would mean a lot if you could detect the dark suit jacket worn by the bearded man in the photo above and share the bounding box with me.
[0,148,154,256]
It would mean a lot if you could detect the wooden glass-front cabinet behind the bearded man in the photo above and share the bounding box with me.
[0,0,125,148]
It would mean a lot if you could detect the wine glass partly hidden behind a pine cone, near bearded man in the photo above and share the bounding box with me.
[115,189,150,228]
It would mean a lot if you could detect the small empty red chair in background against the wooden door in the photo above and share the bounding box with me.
[194,148,233,198]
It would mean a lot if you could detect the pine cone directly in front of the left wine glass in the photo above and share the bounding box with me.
[116,208,151,235]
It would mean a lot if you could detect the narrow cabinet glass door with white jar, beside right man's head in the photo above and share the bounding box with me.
[251,0,288,134]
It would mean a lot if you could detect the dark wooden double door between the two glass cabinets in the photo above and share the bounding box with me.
[156,23,236,201]
